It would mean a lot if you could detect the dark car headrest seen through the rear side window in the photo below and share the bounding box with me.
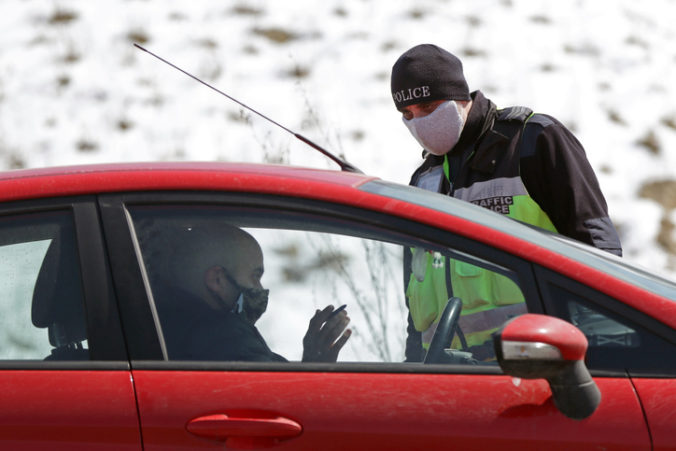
[31,237,87,348]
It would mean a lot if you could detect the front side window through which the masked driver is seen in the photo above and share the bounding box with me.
[129,206,526,364]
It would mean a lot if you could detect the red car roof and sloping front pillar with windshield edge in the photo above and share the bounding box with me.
[0,162,676,328]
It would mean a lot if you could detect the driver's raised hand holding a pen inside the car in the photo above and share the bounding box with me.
[303,305,352,362]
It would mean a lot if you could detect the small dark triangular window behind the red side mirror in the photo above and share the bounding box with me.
[546,282,676,375]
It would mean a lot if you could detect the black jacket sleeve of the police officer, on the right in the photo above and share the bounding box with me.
[521,114,622,255]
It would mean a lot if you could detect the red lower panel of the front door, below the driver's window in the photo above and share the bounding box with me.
[134,371,650,451]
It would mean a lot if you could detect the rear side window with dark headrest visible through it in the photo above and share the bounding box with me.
[0,212,89,360]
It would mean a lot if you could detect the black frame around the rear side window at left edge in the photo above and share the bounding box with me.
[0,196,129,370]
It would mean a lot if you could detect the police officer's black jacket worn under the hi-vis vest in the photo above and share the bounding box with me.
[404,91,622,360]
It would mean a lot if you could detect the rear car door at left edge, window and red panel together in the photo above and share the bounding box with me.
[0,198,141,450]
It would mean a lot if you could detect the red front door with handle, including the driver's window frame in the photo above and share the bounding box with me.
[101,193,650,450]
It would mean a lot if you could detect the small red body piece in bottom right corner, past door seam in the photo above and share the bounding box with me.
[633,379,676,451]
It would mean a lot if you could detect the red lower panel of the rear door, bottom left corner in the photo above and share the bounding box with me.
[0,370,141,451]
